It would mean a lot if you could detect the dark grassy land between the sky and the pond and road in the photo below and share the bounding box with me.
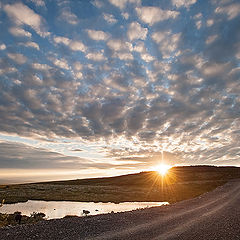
[0,166,240,203]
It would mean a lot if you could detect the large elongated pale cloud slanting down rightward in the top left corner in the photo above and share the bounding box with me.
[4,3,49,37]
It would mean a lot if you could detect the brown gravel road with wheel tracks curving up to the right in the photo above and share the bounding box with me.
[0,179,240,240]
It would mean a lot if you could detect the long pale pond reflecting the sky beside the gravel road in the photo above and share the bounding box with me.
[0,200,168,219]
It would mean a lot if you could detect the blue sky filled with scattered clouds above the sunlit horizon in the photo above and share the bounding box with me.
[0,0,240,183]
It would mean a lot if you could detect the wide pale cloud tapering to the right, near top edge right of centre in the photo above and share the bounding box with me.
[136,7,179,26]
